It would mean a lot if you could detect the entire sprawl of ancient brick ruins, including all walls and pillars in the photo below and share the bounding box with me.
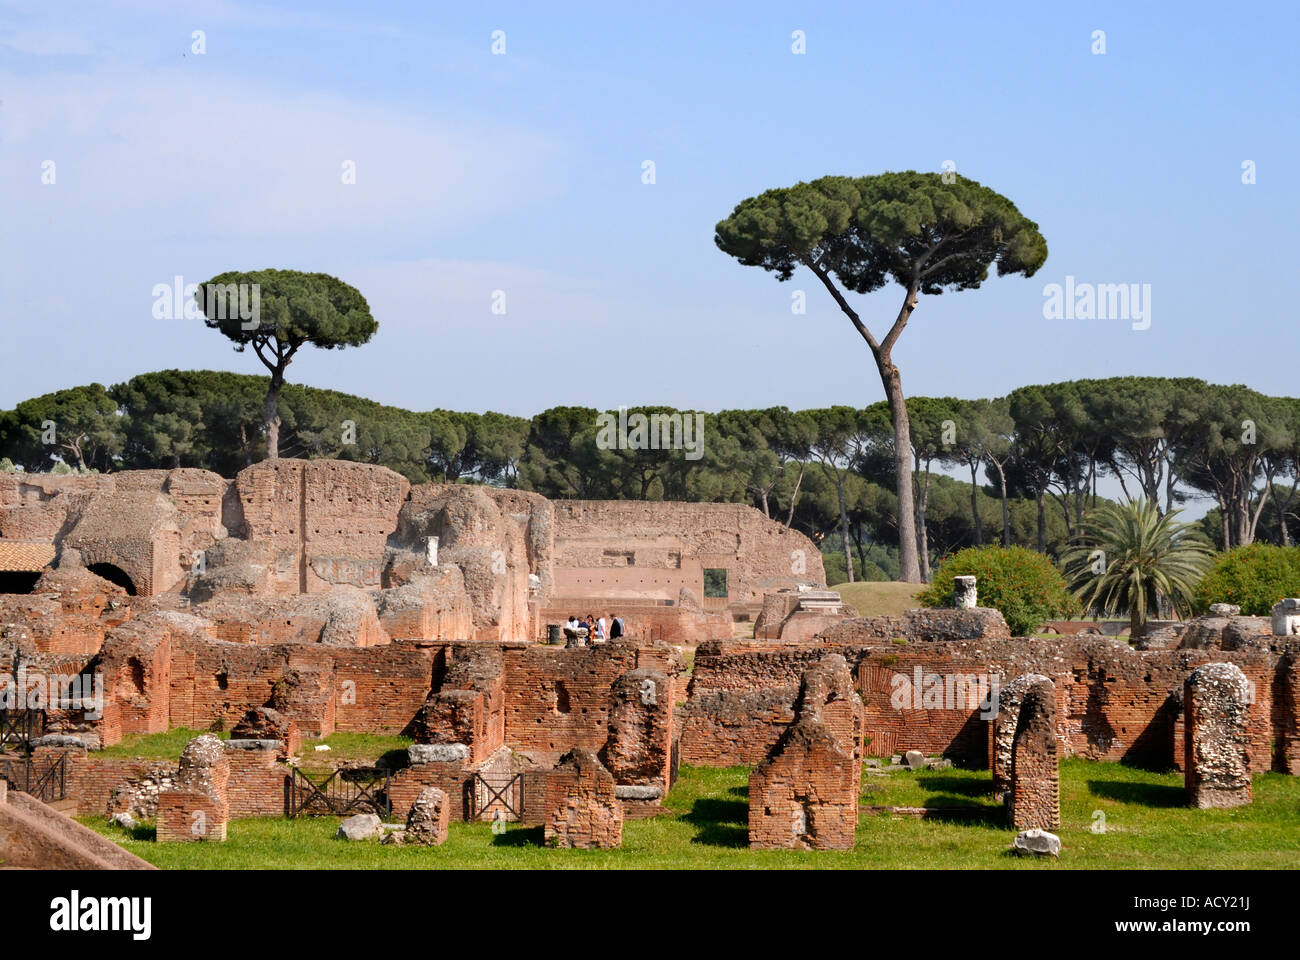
[0,460,1300,849]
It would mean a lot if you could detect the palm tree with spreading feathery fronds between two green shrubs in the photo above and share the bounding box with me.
[1063,500,1214,640]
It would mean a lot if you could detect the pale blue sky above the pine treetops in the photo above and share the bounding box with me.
[0,0,1300,415]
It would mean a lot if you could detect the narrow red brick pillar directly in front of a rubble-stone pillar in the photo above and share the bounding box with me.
[1009,676,1061,830]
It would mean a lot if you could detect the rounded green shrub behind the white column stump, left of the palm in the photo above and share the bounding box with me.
[918,546,1079,636]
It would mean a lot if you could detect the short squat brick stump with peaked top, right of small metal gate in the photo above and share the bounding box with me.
[545,749,623,849]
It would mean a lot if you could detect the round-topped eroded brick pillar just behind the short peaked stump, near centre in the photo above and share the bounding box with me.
[601,660,673,800]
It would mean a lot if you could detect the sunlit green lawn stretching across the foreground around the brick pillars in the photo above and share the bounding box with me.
[82,760,1300,870]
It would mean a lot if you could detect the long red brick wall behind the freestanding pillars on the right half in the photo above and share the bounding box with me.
[681,639,1275,773]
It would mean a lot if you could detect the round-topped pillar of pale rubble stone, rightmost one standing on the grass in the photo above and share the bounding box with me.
[1183,663,1251,809]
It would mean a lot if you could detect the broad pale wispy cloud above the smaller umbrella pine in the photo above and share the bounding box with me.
[0,69,564,241]
